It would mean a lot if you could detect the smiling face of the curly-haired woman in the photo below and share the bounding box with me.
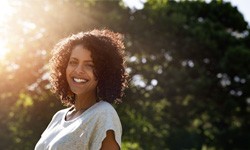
[66,45,98,96]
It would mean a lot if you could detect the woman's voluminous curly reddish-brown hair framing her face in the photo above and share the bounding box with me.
[50,29,128,106]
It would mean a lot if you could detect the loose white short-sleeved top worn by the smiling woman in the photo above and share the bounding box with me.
[35,101,122,150]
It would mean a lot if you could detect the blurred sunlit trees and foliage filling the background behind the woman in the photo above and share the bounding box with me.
[0,0,250,150]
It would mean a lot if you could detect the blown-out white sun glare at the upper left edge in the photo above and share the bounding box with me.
[0,0,13,59]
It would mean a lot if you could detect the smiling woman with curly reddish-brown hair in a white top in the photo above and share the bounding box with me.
[35,30,127,150]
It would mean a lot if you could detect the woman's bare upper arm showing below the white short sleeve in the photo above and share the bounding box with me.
[101,130,120,150]
